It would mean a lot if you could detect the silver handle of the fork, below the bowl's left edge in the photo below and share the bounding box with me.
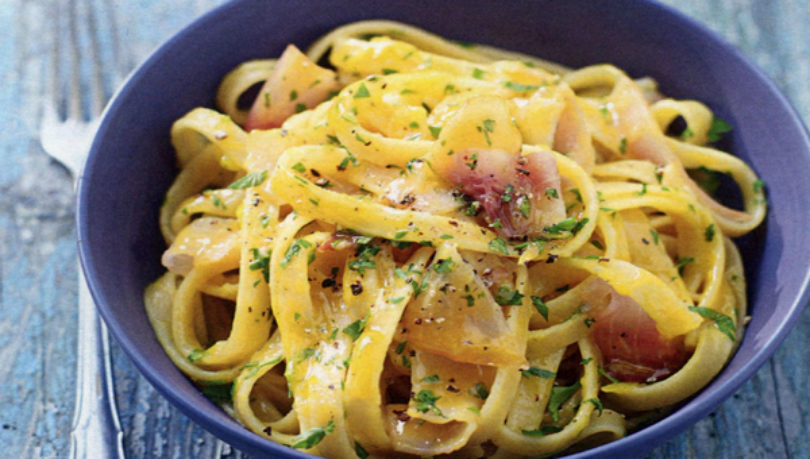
[70,267,125,459]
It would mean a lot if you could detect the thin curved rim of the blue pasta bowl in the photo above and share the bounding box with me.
[75,0,810,459]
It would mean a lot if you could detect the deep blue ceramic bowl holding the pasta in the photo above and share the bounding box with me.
[78,0,810,457]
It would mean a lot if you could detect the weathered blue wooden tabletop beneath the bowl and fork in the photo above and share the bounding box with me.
[0,0,810,458]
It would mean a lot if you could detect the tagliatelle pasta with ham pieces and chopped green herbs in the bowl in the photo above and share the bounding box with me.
[145,21,766,458]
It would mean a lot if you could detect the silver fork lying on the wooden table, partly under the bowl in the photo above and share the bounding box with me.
[40,0,125,458]
